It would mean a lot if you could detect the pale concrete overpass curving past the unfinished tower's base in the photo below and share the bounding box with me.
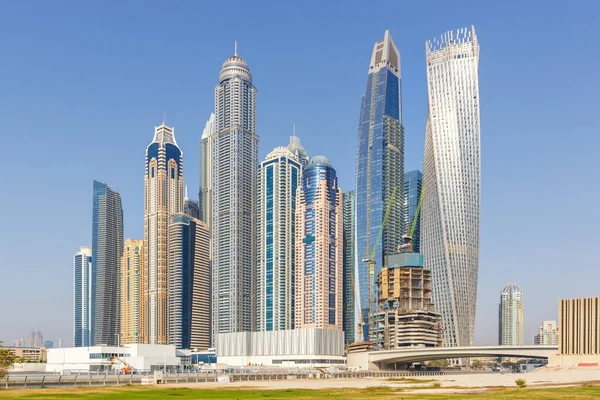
[347,345,558,370]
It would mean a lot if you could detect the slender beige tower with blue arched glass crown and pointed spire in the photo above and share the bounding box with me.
[140,122,184,344]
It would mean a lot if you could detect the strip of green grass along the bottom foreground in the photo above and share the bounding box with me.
[0,386,600,400]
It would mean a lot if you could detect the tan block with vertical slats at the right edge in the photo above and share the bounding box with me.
[548,297,600,366]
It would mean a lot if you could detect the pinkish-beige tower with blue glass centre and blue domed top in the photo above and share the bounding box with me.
[295,156,344,330]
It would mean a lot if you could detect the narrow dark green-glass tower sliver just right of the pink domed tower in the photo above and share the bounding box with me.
[342,190,357,343]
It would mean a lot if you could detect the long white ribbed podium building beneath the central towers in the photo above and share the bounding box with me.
[215,328,346,368]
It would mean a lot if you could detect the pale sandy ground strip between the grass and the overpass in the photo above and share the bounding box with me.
[165,367,600,393]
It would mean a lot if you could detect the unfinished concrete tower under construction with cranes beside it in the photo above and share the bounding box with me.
[370,235,442,350]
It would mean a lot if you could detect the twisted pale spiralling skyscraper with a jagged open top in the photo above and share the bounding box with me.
[420,28,481,346]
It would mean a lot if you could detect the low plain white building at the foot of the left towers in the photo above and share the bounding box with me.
[46,344,181,374]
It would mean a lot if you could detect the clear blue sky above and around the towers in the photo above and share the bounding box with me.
[0,0,600,345]
